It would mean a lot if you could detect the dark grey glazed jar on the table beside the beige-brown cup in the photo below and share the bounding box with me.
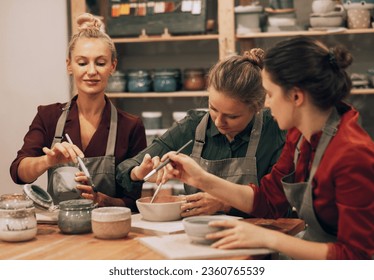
[58,199,94,234]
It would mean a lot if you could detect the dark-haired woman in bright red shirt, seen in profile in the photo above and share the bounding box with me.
[163,37,374,259]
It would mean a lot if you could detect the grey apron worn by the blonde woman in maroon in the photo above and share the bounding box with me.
[48,101,117,205]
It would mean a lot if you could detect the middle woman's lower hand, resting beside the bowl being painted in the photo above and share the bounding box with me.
[181,192,230,217]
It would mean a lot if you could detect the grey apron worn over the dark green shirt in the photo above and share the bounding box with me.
[184,110,263,194]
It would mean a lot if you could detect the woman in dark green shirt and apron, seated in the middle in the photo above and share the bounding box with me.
[117,49,285,217]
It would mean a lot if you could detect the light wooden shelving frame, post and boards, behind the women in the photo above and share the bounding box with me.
[70,0,374,121]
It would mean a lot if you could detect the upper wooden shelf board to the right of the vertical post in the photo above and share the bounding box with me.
[236,28,374,40]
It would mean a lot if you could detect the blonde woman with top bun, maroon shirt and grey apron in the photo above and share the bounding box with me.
[10,14,146,210]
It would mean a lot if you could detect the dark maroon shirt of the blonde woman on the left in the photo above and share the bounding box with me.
[10,96,147,210]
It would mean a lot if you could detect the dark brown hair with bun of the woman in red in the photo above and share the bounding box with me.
[264,36,352,110]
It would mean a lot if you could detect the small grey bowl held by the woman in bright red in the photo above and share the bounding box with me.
[182,215,235,245]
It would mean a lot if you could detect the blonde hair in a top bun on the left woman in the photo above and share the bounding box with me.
[68,13,117,62]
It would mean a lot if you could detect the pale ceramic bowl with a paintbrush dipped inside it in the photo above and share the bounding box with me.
[136,195,185,222]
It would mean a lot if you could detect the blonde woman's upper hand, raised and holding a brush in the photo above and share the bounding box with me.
[43,142,84,167]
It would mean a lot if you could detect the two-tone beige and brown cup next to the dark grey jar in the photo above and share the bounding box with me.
[91,206,131,239]
